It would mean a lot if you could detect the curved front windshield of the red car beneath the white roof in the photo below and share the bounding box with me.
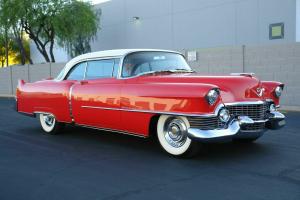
[122,52,192,77]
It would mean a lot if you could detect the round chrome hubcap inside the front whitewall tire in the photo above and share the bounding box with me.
[164,118,187,148]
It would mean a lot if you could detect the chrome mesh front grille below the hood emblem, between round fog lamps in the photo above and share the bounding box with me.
[226,104,267,120]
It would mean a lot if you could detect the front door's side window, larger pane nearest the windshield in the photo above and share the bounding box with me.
[86,59,115,80]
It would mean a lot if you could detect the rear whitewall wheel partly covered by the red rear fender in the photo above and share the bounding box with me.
[39,113,63,135]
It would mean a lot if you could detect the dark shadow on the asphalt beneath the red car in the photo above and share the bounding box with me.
[52,126,272,161]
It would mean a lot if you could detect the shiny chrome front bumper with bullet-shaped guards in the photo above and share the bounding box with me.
[188,111,285,141]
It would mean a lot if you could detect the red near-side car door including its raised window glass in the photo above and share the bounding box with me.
[71,59,123,129]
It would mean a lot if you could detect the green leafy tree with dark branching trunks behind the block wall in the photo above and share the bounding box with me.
[0,0,99,62]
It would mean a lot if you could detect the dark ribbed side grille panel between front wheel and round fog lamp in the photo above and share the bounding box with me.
[188,117,224,130]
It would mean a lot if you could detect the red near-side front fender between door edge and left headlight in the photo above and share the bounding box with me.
[121,83,221,115]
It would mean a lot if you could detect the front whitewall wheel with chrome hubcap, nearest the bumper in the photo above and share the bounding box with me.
[157,115,199,157]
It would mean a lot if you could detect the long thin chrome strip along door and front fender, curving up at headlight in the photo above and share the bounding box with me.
[81,104,224,117]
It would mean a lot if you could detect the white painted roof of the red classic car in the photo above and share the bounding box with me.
[56,49,180,80]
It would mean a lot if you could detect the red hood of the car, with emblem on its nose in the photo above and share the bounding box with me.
[139,73,263,103]
